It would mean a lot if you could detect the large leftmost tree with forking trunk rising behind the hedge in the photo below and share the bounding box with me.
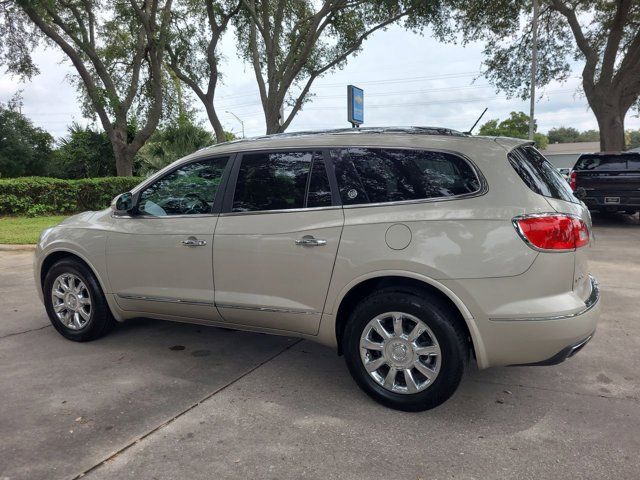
[0,0,171,175]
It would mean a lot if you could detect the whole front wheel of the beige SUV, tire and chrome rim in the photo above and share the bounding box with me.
[43,259,116,342]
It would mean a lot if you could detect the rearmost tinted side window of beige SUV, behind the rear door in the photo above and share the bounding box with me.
[331,148,480,205]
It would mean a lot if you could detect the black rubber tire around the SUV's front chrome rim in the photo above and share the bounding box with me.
[43,258,116,342]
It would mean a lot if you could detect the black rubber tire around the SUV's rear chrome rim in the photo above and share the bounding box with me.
[342,291,469,412]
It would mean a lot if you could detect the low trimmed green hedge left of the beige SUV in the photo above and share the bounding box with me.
[0,177,143,217]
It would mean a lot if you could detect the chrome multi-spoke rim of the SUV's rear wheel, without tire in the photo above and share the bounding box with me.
[360,312,442,394]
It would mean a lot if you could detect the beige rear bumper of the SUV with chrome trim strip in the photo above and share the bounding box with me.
[482,277,600,366]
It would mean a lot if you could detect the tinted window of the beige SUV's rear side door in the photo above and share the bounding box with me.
[233,152,322,212]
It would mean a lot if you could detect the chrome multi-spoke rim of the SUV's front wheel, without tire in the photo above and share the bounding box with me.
[51,273,91,330]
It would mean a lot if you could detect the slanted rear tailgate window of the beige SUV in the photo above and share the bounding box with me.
[508,145,578,203]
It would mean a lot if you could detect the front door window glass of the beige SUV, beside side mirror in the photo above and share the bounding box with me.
[138,158,229,217]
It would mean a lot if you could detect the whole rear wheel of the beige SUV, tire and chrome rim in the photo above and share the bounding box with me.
[342,291,469,411]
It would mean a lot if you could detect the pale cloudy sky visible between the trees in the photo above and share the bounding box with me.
[0,27,640,138]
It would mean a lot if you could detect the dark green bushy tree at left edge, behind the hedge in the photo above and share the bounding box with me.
[0,96,53,177]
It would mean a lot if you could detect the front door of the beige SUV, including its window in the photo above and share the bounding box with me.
[106,157,228,320]
